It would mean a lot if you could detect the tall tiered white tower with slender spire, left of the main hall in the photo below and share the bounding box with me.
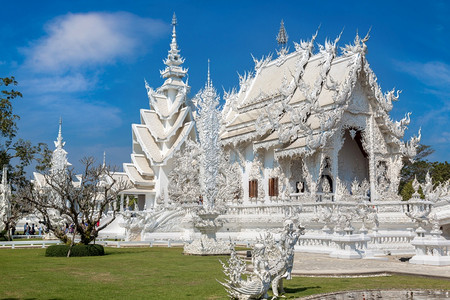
[123,14,196,210]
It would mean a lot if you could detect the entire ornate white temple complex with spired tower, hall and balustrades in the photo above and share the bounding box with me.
[36,15,450,264]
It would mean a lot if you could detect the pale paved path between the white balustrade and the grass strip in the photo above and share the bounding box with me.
[292,252,450,279]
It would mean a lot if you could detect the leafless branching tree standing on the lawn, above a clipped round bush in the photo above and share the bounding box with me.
[21,157,129,245]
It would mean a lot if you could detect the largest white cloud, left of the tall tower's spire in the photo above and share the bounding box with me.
[22,12,168,73]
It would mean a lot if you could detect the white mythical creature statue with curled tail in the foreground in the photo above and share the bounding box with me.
[221,219,304,300]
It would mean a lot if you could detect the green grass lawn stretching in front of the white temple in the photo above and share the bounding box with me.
[0,248,450,300]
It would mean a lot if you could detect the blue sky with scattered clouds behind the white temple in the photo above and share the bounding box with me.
[0,0,450,172]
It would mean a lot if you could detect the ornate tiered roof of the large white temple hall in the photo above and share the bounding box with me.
[221,30,418,161]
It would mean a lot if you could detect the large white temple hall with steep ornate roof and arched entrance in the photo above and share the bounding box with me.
[221,26,420,203]
